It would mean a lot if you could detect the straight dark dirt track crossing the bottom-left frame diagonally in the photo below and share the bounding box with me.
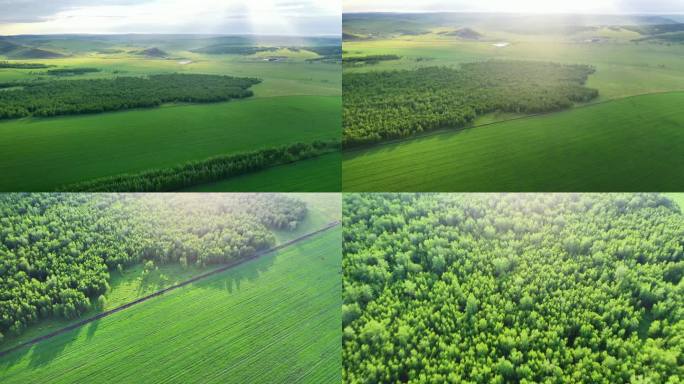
[0,220,341,357]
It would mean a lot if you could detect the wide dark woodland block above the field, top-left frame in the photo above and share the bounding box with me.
[0,74,260,119]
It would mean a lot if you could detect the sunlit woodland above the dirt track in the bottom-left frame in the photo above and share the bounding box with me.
[0,193,306,339]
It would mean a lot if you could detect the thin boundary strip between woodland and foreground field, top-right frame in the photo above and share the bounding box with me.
[342,90,684,154]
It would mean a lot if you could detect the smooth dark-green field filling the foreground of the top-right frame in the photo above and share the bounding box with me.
[342,93,684,192]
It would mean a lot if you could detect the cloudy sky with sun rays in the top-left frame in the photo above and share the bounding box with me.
[0,0,342,36]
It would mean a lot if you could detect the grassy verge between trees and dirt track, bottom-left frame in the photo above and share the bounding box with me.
[0,193,342,350]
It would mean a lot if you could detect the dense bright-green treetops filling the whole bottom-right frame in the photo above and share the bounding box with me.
[342,194,684,384]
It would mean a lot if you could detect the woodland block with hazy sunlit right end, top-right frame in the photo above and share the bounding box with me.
[342,61,598,146]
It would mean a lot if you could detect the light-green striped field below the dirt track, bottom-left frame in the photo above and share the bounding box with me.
[0,228,342,384]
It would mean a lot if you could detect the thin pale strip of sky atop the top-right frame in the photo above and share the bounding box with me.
[342,0,684,14]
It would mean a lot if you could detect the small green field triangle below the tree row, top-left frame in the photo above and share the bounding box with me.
[183,153,342,192]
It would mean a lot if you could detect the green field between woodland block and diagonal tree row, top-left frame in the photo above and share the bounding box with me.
[0,96,341,191]
